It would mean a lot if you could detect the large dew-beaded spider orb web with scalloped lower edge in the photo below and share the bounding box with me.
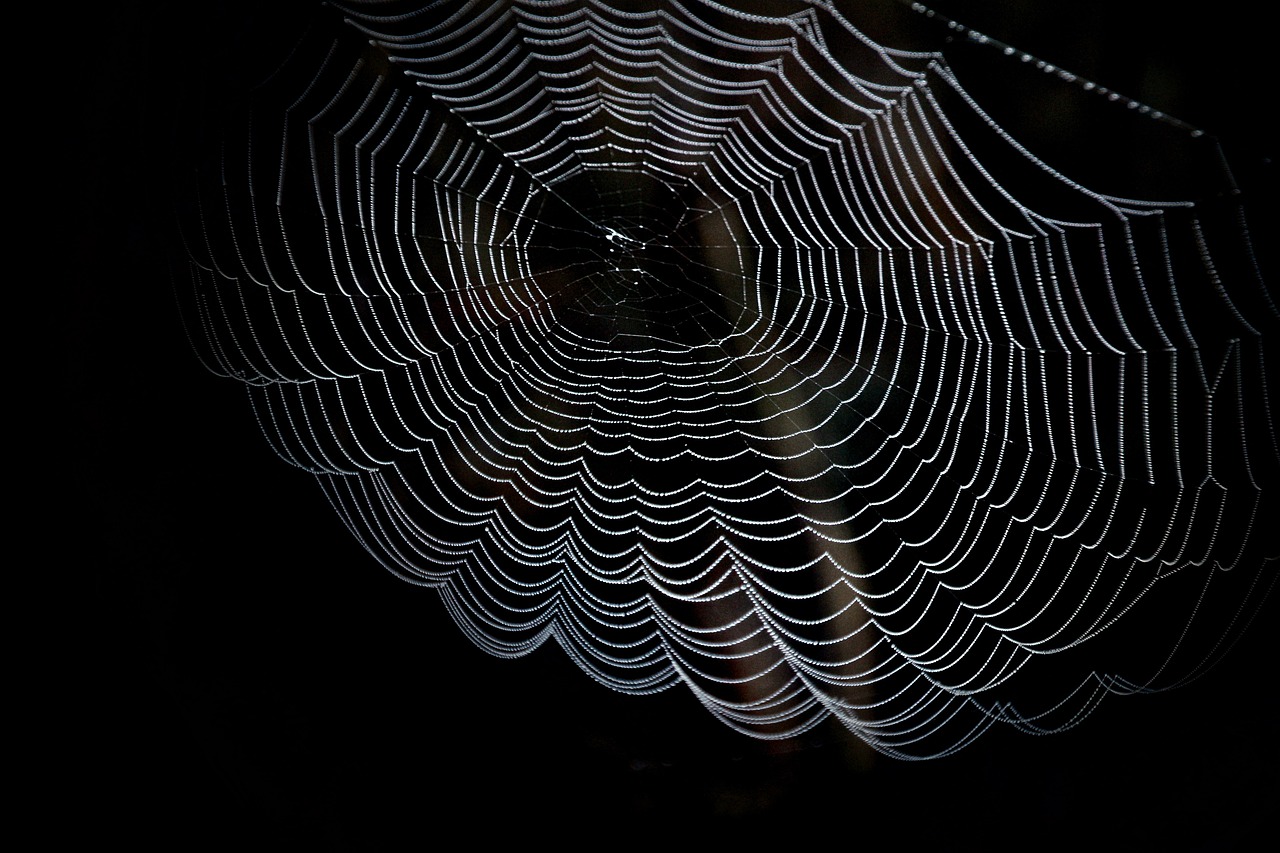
[187,0,1280,756]
